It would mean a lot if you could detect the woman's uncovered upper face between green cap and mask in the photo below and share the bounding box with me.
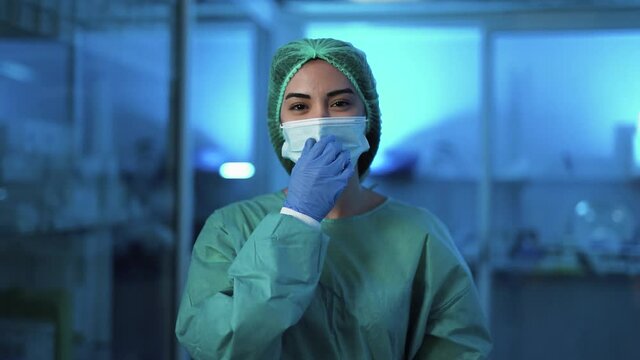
[280,60,365,123]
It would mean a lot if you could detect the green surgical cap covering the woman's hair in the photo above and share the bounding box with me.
[267,39,380,178]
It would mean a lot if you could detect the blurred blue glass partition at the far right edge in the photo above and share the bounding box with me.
[492,30,640,359]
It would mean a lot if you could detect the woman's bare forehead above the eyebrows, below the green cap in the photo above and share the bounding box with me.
[286,60,355,92]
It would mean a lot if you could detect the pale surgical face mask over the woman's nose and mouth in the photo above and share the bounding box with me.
[280,116,369,167]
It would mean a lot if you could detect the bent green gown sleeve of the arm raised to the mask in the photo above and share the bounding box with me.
[176,213,328,359]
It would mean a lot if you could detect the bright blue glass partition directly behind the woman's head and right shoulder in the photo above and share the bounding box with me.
[306,22,482,263]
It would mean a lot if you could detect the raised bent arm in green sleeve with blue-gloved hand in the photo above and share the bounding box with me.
[176,136,353,359]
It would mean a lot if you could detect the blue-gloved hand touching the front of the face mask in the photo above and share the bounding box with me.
[284,135,354,222]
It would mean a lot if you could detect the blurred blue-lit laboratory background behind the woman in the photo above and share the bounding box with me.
[0,0,640,360]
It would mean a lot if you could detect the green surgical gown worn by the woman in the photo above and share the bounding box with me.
[176,192,491,360]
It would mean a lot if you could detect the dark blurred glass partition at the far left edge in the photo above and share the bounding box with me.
[0,1,175,359]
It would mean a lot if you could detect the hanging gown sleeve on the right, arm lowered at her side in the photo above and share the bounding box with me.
[408,215,492,359]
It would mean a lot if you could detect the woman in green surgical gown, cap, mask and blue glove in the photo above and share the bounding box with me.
[176,39,491,359]
